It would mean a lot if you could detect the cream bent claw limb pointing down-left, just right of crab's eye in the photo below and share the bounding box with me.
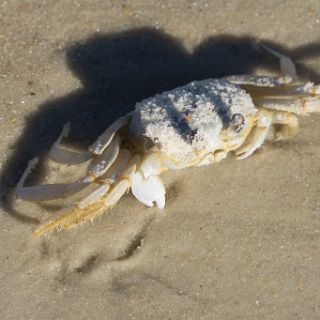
[236,109,272,160]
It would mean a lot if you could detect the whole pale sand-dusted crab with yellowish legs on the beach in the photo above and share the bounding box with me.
[16,44,320,236]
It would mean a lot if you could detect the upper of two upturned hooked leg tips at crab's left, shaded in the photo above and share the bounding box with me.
[49,122,92,165]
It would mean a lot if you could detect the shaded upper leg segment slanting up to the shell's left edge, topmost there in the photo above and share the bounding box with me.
[89,113,131,154]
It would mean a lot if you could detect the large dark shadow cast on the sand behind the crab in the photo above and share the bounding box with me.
[0,28,320,223]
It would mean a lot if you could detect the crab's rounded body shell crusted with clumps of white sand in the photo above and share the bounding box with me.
[129,79,257,169]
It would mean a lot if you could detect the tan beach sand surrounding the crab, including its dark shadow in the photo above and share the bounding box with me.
[0,0,320,320]
